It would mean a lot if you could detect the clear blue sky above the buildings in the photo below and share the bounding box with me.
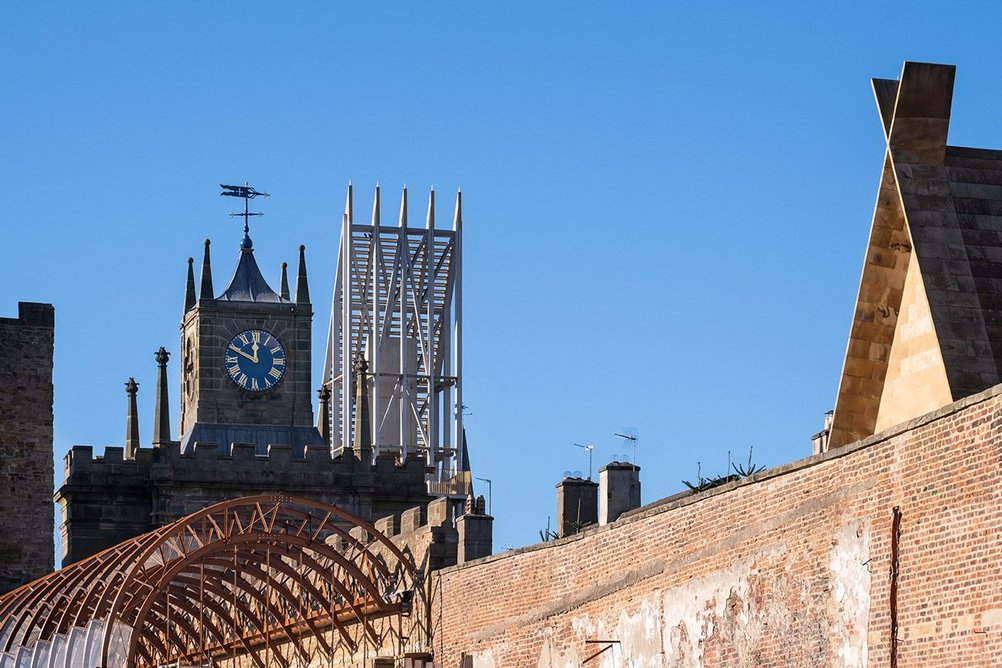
[0,2,1002,549]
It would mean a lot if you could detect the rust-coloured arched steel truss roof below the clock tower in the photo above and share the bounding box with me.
[0,497,420,668]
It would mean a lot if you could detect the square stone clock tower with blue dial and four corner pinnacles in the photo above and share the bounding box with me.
[180,227,324,457]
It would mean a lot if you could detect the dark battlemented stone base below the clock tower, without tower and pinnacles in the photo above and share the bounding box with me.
[50,442,431,566]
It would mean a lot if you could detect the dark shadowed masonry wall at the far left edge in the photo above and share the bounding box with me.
[0,302,55,593]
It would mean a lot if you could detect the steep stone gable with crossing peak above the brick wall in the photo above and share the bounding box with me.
[828,62,1002,448]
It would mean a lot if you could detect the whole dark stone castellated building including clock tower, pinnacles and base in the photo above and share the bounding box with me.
[49,227,431,565]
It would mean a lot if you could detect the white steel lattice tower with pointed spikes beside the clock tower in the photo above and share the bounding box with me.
[324,184,470,494]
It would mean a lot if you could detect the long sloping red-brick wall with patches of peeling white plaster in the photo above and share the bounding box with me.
[431,386,1002,668]
